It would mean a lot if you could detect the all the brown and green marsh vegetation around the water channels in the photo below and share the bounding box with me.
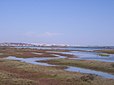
[0,48,114,85]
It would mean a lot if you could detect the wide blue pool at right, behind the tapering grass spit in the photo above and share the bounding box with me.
[64,51,114,62]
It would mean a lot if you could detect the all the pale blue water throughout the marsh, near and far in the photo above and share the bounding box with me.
[7,47,114,79]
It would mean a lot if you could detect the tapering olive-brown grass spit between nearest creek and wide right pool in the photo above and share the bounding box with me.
[42,59,114,73]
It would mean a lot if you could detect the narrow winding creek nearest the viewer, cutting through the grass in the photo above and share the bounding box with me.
[6,56,114,79]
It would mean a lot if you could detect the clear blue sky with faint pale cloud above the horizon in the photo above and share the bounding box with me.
[0,0,114,46]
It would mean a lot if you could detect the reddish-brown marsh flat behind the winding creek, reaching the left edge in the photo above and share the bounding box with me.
[0,48,77,58]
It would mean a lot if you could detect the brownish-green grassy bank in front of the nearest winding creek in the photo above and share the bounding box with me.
[0,59,114,85]
